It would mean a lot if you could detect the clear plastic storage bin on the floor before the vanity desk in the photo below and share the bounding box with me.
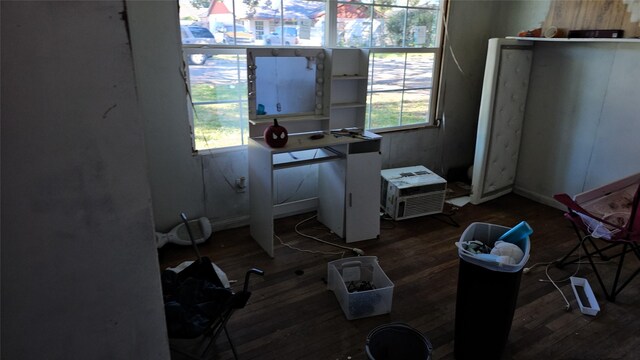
[327,256,393,320]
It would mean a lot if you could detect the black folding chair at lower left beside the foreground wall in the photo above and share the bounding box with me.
[162,213,264,359]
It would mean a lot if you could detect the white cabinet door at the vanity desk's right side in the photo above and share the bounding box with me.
[345,151,381,243]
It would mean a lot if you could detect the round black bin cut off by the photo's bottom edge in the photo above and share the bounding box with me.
[365,323,433,360]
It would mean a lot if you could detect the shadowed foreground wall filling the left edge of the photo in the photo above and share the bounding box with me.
[0,1,169,359]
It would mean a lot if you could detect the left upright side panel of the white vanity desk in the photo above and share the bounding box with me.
[249,140,273,257]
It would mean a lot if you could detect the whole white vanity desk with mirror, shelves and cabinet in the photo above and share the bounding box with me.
[247,47,382,257]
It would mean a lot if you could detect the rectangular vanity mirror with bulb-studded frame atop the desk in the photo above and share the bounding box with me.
[247,48,328,124]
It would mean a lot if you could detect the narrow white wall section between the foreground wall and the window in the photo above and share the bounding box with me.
[126,0,205,231]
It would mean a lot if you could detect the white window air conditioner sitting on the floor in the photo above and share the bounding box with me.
[380,166,447,220]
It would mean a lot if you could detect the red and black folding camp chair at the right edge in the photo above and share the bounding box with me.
[554,173,640,302]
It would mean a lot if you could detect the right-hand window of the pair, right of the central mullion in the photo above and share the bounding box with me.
[336,0,441,131]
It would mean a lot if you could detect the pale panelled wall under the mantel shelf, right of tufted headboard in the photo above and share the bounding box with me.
[516,43,640,206]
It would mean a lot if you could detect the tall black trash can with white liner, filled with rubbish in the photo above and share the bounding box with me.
[454,223,530,360]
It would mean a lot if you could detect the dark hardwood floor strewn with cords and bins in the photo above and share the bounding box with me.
[159,194,640,360]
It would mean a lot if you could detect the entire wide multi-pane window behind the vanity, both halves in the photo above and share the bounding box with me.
[179,0,446,150]
